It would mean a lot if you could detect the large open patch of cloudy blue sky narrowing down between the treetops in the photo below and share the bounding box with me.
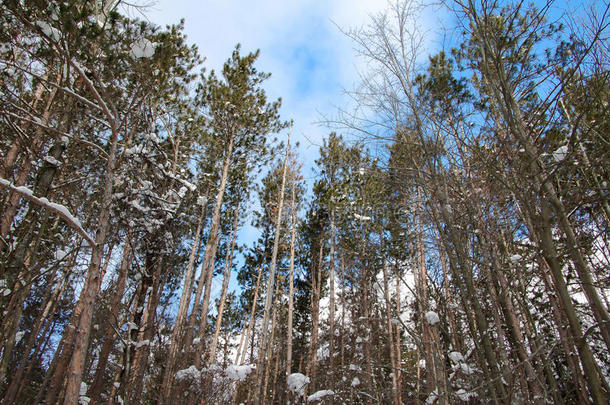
[145,0,385,166]
